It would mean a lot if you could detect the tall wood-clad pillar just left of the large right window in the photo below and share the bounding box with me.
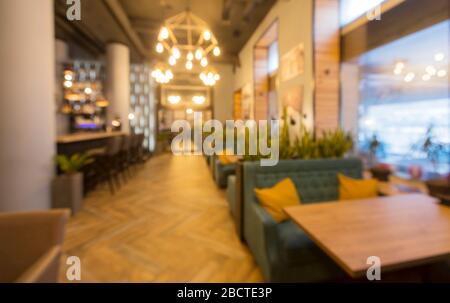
[314,0,340,134]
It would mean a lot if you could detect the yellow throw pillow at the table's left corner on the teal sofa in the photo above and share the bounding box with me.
[255,178,300,223]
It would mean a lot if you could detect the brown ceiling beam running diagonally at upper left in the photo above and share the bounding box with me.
[103,0,148,58]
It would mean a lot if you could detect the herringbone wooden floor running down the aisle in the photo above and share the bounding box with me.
[60,155,262,282]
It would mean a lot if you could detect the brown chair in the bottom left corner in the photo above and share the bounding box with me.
[0,210,70,283]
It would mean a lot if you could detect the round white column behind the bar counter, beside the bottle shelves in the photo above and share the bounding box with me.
[106,43,130,133]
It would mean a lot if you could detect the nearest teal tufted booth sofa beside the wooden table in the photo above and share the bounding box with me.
[242,159,362,282]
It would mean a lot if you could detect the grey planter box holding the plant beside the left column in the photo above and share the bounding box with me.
[52,173,83,215]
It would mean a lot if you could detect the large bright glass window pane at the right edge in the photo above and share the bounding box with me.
[344,21,450,173]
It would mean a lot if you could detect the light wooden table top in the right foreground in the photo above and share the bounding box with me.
[285,194,450,278]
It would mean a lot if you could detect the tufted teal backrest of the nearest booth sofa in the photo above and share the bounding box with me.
[244,158,362,203]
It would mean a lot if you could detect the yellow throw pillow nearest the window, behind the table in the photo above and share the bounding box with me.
[338,174,378,200]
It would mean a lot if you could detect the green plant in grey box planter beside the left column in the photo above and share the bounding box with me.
[52,154,94,214]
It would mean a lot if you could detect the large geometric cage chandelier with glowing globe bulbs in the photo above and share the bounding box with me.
[155,10,221,86]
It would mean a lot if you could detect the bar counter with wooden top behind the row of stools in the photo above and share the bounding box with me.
[56,132,125,155]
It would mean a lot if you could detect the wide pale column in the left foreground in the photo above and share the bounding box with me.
[0,0,55,212]
